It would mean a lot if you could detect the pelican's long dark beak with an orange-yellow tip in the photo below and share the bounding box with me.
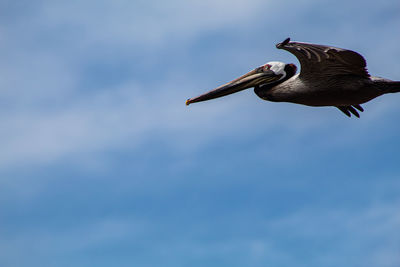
[186,67,282,105]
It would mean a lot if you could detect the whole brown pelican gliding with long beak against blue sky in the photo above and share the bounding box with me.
[186,38,400,118]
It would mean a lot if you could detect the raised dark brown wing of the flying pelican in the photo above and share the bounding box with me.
[276,38,369,80]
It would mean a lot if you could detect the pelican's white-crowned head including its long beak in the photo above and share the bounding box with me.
[186,61,297,105]
